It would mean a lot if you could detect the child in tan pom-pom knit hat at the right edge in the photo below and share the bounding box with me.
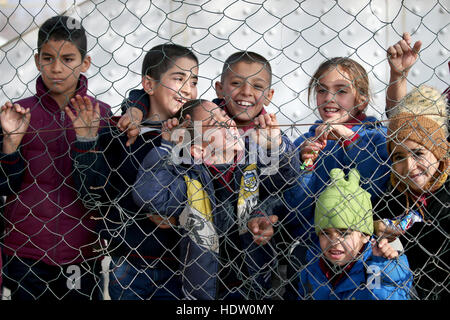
[375,85,450,301]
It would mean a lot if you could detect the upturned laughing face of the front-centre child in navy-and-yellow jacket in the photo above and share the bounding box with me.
[194,102,242,163]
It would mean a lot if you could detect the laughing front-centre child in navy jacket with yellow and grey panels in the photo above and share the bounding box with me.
[133,100,297,300]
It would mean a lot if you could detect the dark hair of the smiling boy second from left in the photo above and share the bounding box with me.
[142,43,198,80]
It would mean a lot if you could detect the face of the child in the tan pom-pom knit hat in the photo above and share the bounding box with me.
[391,140,439,192]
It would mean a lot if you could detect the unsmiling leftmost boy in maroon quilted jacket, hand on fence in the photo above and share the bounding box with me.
[2,16,110,300]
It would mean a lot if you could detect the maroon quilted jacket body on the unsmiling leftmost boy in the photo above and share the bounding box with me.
[4,75,110,265]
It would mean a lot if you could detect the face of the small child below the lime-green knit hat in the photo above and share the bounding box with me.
[319,228,369,266]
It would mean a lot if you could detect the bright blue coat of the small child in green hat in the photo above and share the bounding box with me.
[298,243,413,300]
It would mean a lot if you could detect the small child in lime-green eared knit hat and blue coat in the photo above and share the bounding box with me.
[298,169,412,300]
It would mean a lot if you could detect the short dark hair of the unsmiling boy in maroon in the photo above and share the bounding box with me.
[37,16,87,59]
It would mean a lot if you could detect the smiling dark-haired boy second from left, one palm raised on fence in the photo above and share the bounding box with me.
[69,44,198,300]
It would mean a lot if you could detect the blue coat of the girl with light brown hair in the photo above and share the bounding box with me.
[283,117,390,240]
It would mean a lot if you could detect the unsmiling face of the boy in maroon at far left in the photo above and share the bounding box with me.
[35,40,91,102]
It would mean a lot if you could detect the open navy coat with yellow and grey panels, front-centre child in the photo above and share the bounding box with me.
[133,137,298,300]
